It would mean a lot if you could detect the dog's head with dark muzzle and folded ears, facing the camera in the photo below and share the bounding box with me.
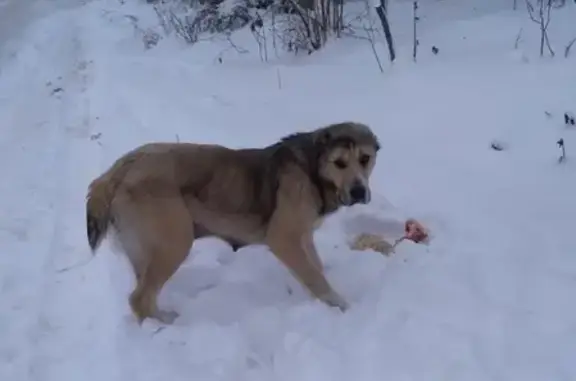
[314,122,380,206]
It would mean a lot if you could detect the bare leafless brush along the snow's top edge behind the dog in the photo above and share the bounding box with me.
[153,0,343,53]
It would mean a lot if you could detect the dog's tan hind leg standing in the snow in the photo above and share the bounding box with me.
[125,197,194,324]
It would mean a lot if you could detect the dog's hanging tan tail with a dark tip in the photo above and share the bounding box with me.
[86,155,137,254]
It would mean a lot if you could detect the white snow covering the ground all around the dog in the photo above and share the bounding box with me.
[0,0,576,381]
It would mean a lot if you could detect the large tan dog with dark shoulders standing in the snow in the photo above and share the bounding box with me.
[86,122,380,324]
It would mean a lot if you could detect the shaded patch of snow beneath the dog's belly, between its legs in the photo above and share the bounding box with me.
[159,247,306,326]
